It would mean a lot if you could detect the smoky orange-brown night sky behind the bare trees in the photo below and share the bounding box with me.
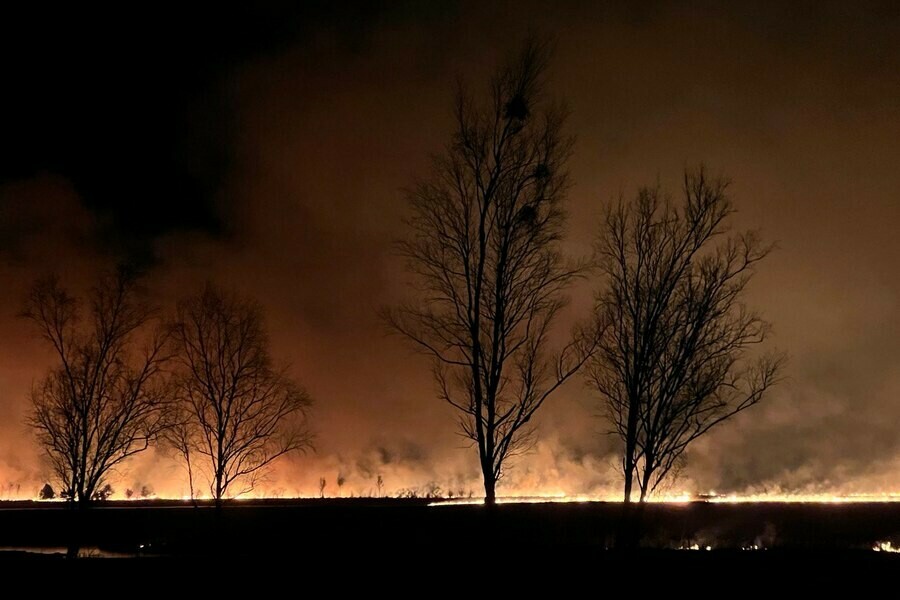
[0,2,900,498]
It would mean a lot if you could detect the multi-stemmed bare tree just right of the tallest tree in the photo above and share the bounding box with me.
[589,167,783,502]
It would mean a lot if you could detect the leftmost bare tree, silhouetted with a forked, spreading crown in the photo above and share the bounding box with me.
[22,269,167,506]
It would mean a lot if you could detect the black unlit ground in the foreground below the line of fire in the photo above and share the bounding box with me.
[0,499,900,598]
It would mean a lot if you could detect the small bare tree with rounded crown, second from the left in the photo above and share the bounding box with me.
[170,284,312,507]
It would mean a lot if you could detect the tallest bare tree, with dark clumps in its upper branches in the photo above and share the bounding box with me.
[388,39,592,504]
